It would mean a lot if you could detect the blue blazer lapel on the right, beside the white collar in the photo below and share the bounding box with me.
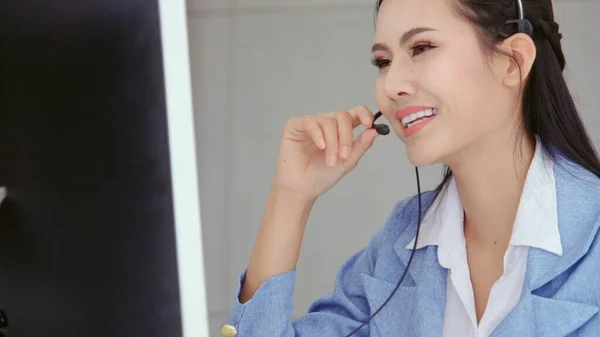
[491,159,600,337]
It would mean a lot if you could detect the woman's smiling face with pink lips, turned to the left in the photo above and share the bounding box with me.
[373,0,515,165]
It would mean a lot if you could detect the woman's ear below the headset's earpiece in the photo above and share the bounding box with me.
[497,33,537,88]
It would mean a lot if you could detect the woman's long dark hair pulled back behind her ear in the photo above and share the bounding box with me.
[375,0,600,200]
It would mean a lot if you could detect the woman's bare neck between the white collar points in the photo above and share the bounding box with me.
[449,130,535,249]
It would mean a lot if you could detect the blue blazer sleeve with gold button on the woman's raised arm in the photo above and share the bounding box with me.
[228,223,384,337]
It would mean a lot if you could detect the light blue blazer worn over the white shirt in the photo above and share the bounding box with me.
[227,157,600,337]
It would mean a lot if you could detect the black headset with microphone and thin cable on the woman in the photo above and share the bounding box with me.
[345,0,533,337]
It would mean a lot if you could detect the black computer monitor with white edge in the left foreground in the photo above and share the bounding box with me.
[0,0,208,337]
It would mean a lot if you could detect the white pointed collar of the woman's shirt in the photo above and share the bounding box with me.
[406,140,563,256]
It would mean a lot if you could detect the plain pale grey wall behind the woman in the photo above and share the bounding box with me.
[188,0,600,335]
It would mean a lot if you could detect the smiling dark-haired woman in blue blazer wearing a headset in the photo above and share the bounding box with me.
[223,0,600,337]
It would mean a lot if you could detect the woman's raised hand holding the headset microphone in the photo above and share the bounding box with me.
[273,106,378,200]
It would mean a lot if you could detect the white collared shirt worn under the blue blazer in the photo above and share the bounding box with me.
[406,141,563,337]
